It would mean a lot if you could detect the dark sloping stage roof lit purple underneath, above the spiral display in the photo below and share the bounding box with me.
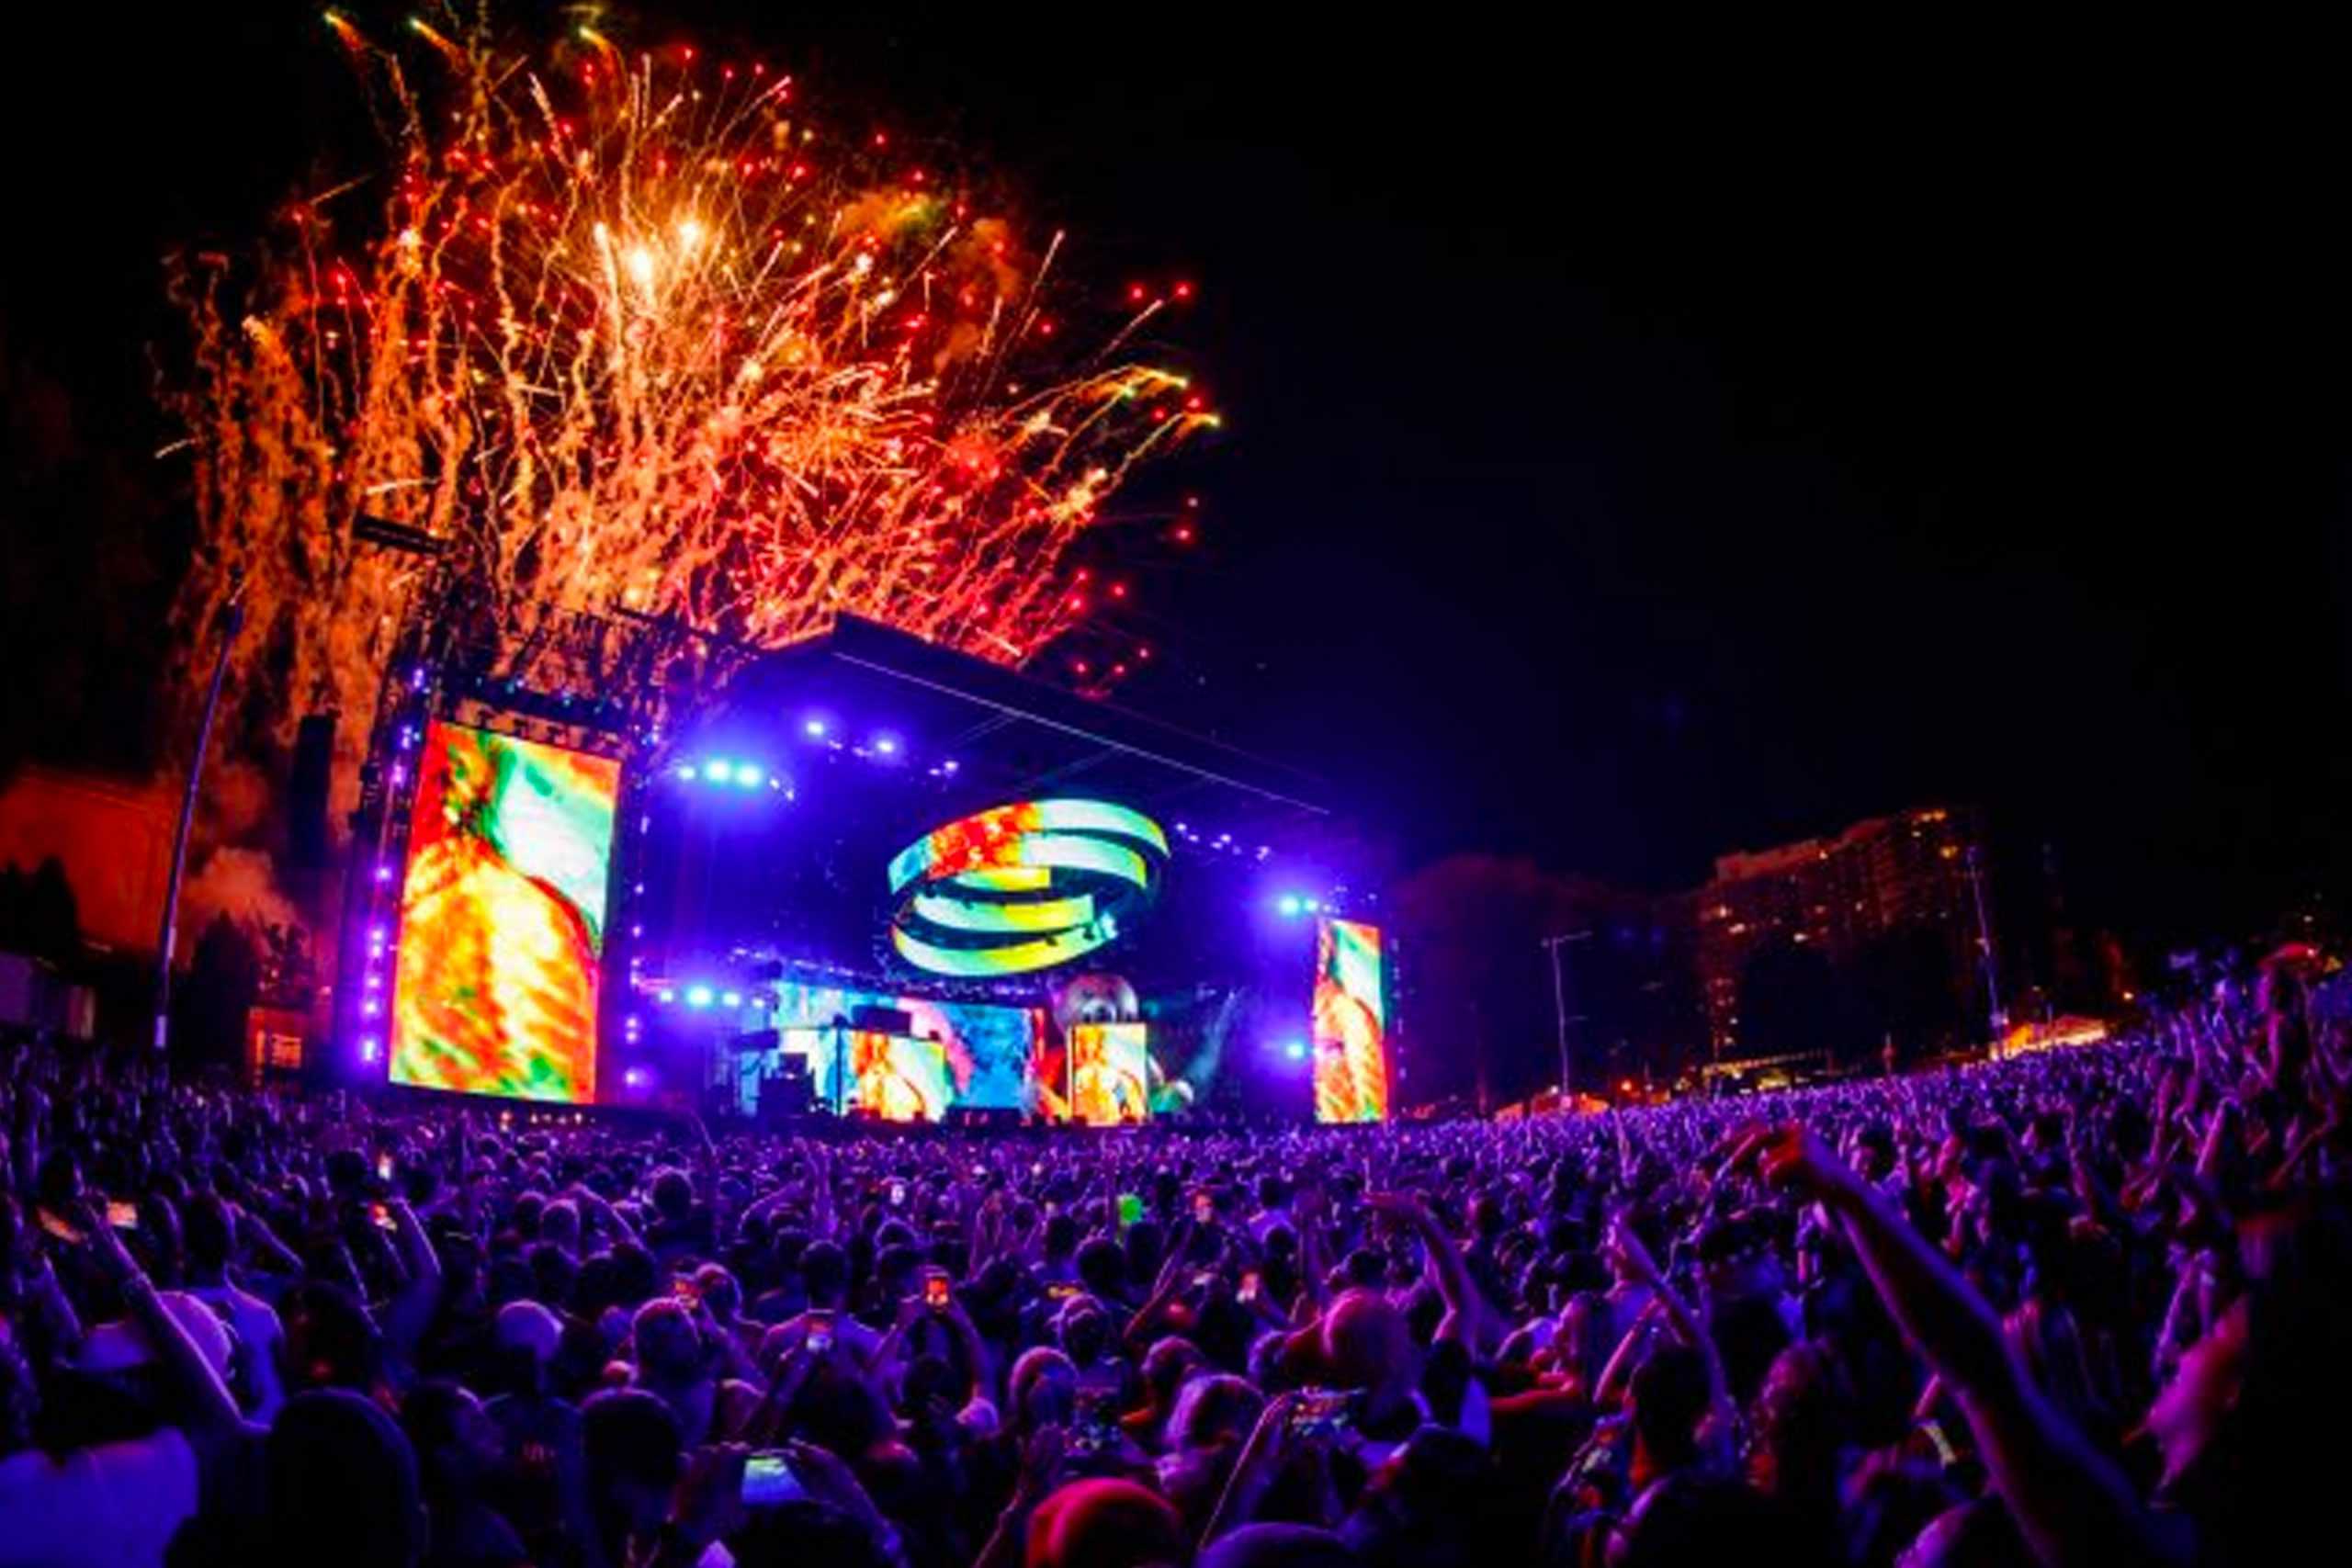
[665,616,1336,840]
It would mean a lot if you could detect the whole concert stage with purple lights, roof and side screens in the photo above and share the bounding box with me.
[350,618,1395,1126]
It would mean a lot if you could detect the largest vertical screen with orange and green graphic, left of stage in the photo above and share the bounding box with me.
[390,719,621,1102]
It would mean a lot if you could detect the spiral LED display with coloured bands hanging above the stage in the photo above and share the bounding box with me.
[889,799,1169,976]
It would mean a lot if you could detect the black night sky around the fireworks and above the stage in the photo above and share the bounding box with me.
[0,3,2352,936]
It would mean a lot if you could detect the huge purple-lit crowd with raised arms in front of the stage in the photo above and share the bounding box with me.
[0,949,2352,1568]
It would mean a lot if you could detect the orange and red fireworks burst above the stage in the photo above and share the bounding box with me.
[172,12,1216,771]
